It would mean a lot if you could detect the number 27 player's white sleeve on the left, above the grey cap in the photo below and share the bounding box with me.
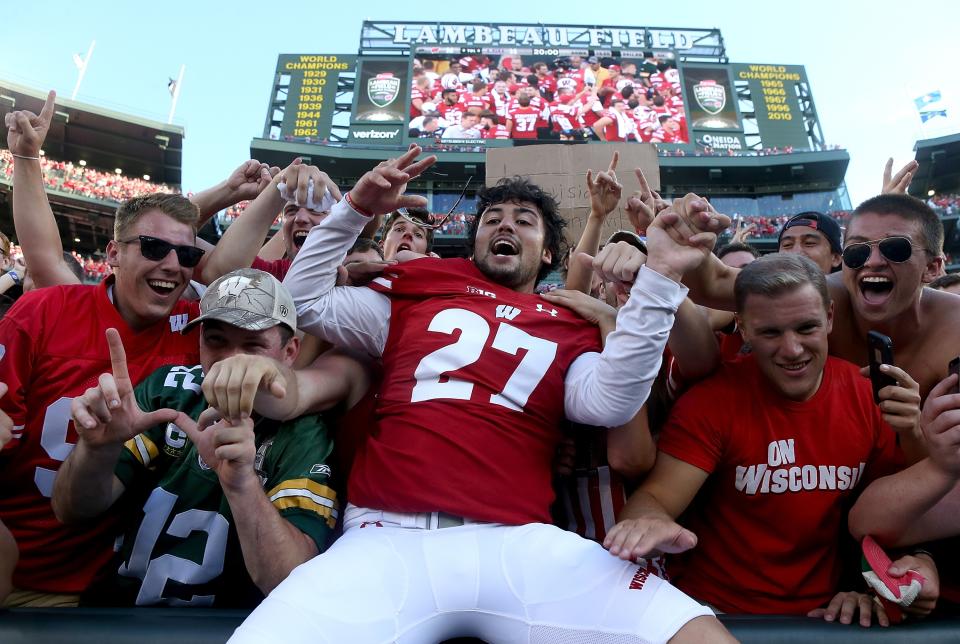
[283,199,390,357]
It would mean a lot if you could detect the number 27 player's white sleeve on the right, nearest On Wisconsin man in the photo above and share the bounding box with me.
[563,266,687,427]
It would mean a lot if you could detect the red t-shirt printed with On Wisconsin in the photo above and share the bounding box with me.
[658,355,902,614]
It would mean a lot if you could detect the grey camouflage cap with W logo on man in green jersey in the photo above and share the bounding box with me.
[182,268,297,333]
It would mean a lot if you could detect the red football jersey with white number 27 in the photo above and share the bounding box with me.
[350,258,600,525]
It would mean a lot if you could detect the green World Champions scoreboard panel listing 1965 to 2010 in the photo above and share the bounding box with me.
[731,63,810,149]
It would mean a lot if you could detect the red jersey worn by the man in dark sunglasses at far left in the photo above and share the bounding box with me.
[0,278,200,593]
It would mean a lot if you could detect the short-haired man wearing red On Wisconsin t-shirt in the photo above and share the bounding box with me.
[605,253,920,626]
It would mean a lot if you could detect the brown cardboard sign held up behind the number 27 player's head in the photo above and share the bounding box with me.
[486,143,660,244]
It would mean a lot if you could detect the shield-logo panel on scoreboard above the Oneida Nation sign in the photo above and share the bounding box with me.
[681,65,743,132]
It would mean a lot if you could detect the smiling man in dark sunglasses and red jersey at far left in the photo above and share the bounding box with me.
[0,191,203,605]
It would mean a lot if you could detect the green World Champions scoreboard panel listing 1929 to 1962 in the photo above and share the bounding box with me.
[277,54,357,139]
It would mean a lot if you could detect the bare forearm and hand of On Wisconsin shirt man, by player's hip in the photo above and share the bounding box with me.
[603,452,708,561]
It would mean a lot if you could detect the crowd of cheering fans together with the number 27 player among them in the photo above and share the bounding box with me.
[0,87,960,642]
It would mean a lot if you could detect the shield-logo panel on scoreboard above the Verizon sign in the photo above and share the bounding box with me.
[351,58,410,126]
